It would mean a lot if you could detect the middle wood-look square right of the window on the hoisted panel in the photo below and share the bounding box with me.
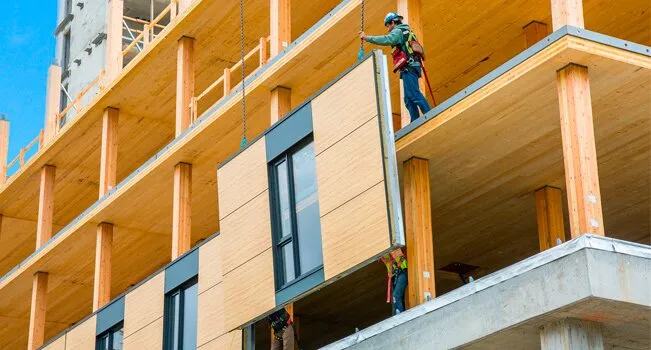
[316,118,384,216]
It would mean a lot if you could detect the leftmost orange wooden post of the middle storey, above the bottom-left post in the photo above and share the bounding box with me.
[36,165,56,249]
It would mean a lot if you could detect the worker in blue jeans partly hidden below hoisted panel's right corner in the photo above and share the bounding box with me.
[380,248,407,315]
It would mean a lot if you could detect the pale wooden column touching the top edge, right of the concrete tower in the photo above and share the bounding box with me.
[104,0,124,82]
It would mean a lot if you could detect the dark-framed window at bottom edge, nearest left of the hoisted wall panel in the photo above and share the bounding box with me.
[163,277,197,350]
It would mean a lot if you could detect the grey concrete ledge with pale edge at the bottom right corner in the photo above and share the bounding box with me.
[325,235,651,349]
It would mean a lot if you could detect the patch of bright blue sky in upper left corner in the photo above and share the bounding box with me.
[0,0,57,160]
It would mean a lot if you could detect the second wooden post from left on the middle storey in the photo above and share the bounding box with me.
[99,107,120,198]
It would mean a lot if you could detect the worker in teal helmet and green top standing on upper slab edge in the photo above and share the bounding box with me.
[359,12,431,122]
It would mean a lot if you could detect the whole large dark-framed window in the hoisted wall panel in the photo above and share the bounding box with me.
[269,136,323,289]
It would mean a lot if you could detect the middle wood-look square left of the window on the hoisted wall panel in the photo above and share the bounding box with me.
[220,191,271,274]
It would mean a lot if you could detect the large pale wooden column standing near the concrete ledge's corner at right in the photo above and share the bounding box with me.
[556,64,604,238]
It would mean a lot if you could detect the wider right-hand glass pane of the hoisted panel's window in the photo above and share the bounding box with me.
[292,142,323,273]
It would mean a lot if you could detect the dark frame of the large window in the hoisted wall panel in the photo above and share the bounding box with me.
[268,133,323,292]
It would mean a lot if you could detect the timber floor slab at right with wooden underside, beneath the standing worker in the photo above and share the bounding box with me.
[396,36,651,284]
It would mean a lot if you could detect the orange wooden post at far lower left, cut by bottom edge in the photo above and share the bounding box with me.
[27,271,48,350]
